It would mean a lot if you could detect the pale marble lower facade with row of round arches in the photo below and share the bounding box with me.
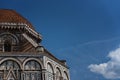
[0,54,70,80]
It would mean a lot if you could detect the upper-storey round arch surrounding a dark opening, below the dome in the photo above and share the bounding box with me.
[0,32,20,52]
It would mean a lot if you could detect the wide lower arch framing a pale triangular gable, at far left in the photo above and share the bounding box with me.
[0,60,21,80]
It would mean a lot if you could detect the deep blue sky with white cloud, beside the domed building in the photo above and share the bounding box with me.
[0,0,120,80]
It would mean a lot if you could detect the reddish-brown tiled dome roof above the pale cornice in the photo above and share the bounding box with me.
[0,9,34,29]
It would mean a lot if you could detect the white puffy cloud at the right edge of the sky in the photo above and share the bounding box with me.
[88,48,120,79]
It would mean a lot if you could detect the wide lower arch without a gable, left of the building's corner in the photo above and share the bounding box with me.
[24,60,42,80]
